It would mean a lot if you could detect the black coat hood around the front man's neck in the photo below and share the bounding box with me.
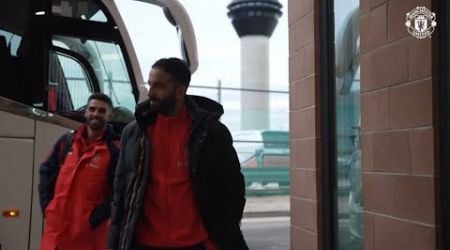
[134,95,224,128]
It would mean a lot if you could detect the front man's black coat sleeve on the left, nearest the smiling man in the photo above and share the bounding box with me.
[107,124,131,249]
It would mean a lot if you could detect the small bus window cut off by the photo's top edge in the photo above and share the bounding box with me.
[52,0,108,23]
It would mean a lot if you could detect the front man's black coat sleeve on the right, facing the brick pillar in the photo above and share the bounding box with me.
[211,123,248,250]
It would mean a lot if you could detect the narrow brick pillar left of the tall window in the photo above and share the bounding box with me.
[288,0,320,250]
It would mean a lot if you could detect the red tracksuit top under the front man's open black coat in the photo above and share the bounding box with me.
[136,106,213,247]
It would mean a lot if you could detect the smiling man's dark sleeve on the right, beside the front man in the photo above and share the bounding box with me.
[89,142,120,229]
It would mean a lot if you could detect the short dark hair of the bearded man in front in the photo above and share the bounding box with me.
[152,57,191,87]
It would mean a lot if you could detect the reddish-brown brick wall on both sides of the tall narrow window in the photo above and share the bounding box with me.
[288,0,437,250]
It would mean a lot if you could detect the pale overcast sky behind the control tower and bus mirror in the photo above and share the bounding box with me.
[118,0,288,90]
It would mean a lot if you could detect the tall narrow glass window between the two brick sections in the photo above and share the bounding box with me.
[334,0,363,250]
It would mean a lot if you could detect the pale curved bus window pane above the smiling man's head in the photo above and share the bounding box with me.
[53,36,136,110]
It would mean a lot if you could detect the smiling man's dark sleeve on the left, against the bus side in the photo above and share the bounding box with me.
[38,134,67,213]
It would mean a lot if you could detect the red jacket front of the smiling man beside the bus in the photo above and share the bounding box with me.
[41,126,116,250]
